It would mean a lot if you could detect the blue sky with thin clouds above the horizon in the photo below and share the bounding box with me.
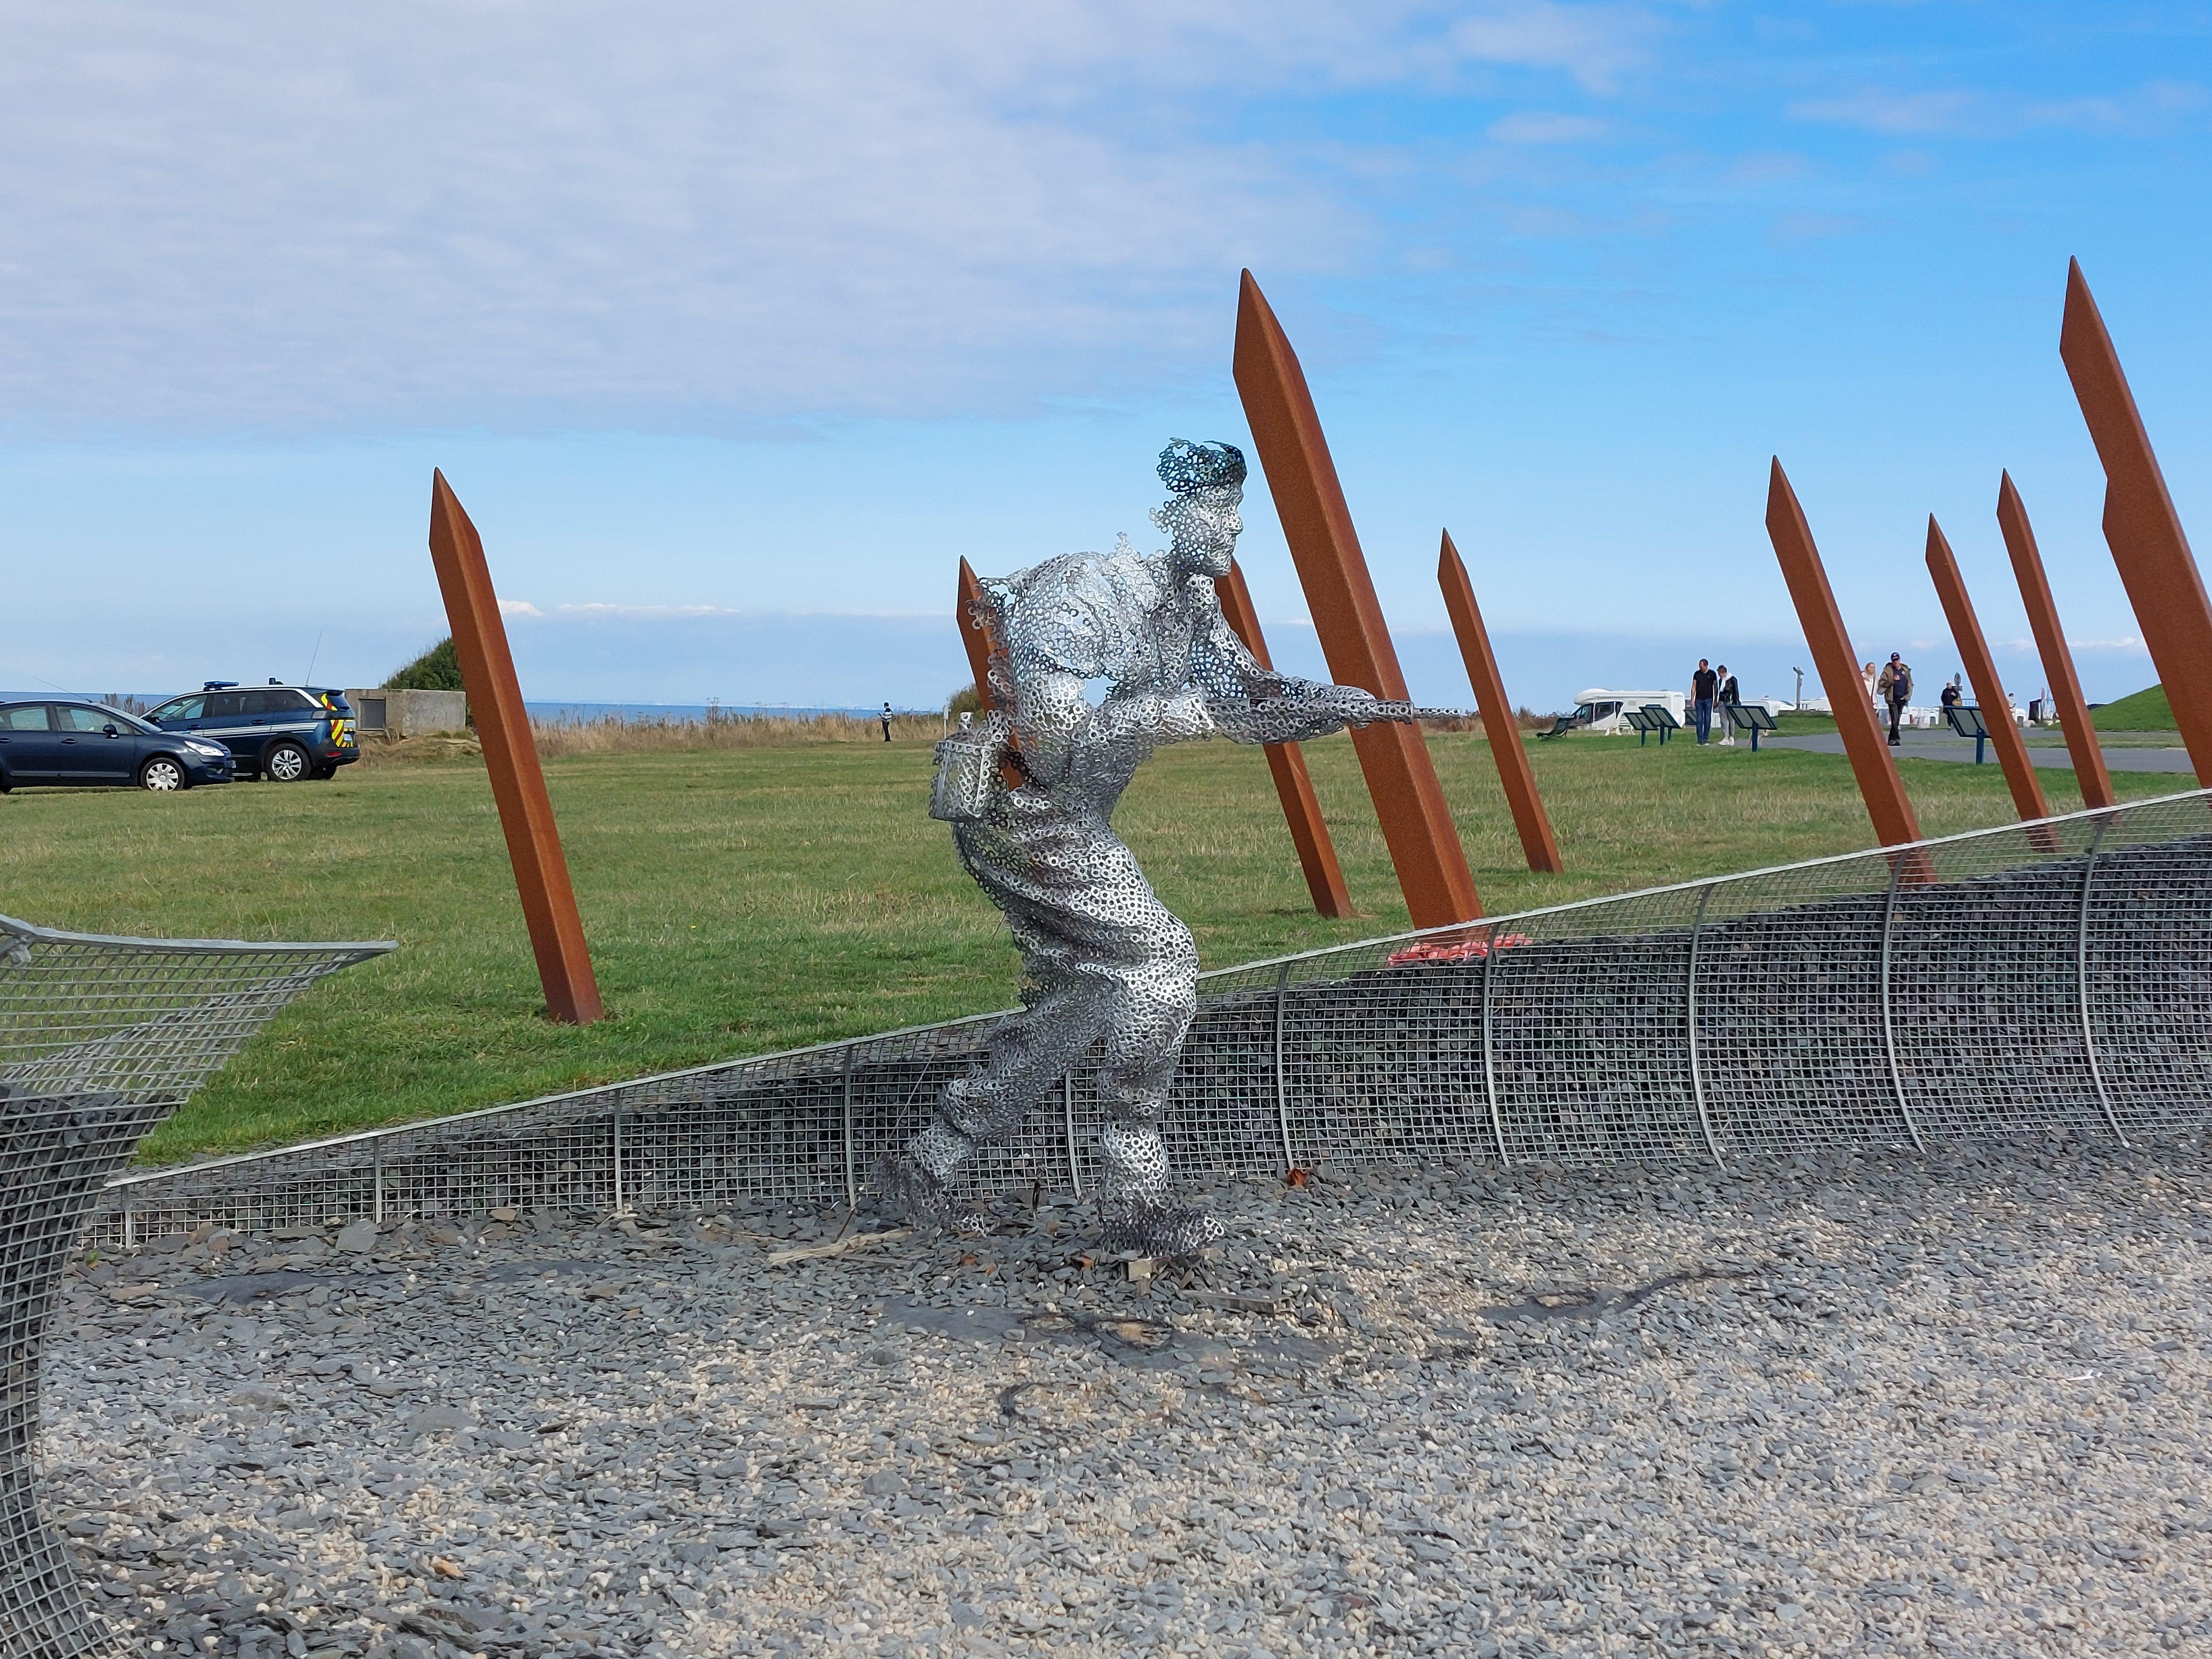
[0,0,2212,708]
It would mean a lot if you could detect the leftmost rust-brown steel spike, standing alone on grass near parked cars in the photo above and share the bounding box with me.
[429,471,599,1027]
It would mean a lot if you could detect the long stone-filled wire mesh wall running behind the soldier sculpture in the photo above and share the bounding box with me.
[97,792,2212,1243]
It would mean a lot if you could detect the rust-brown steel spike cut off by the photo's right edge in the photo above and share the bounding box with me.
[2059,259,2212,785]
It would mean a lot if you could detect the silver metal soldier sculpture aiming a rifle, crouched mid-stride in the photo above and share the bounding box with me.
[880,438,1427,1256]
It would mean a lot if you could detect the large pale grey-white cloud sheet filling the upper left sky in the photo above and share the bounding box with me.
[0,0,1657,431]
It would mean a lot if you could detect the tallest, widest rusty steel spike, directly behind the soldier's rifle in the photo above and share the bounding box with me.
[1234,270,1482,927]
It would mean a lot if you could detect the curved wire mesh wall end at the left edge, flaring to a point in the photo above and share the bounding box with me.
[0,916,391,1659]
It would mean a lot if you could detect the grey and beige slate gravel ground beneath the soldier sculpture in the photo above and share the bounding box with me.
[46,1144,2212,1659]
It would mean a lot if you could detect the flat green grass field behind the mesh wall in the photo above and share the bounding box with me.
[0,734,2188,1161]
